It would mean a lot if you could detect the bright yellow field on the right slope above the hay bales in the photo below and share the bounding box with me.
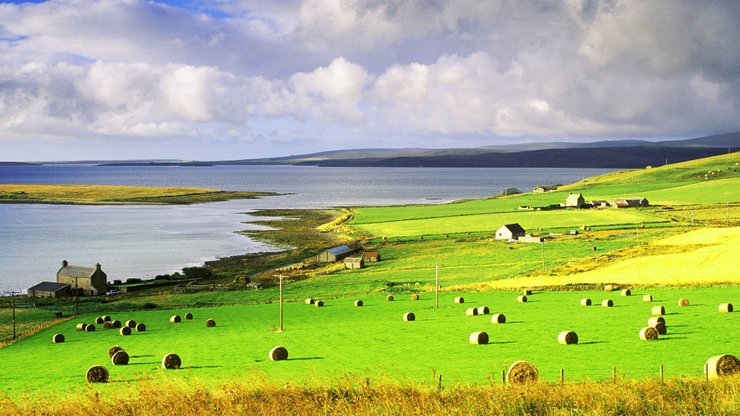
[476,227,740,288]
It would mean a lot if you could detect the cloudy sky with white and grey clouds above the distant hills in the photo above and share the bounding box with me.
[0,0,740,161]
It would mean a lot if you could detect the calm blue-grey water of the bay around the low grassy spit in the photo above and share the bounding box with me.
[0,165,608,290]
